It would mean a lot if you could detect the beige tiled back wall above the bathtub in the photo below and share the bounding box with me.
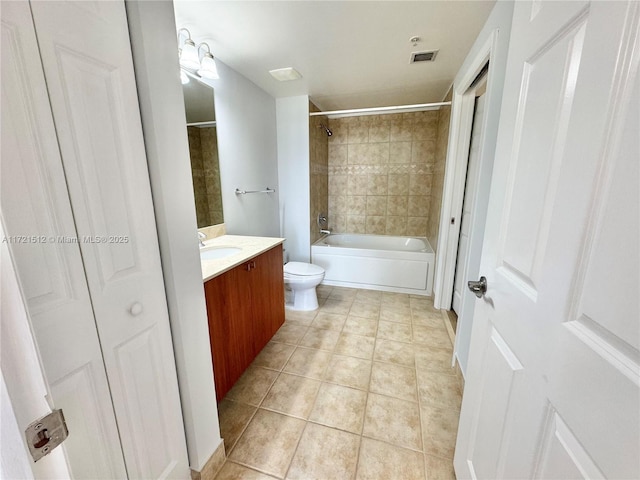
[328,111,441,238]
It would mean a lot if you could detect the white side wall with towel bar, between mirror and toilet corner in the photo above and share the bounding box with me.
[206,62,280,237]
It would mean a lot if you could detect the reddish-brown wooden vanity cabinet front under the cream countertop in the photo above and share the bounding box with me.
[204,245,284,401]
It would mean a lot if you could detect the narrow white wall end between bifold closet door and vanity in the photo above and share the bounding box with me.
[126,1,222,471]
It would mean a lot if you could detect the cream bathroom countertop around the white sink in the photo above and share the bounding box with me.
[200,235,285,282]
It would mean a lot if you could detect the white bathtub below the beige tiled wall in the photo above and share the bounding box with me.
[311,233,435,295]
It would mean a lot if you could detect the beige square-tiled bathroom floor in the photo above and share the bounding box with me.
[217,285,461,480]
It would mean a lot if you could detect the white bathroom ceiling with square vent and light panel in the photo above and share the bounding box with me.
[174,0,494,110]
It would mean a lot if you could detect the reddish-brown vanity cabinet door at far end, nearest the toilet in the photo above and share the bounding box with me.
[250,245,284,355]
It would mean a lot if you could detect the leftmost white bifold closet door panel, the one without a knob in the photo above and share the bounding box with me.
[0,2,126,479]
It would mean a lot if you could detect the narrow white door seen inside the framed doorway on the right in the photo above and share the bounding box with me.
[451,94,486,315]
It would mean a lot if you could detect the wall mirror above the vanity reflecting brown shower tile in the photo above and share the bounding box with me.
[182,71,224,228]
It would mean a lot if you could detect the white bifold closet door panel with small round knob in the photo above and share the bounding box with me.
[31,1,189,478]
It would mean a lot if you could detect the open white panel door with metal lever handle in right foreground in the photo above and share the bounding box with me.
[454,1,640,479]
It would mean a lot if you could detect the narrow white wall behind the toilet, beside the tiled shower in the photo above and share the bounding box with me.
[276,95,311,262]
